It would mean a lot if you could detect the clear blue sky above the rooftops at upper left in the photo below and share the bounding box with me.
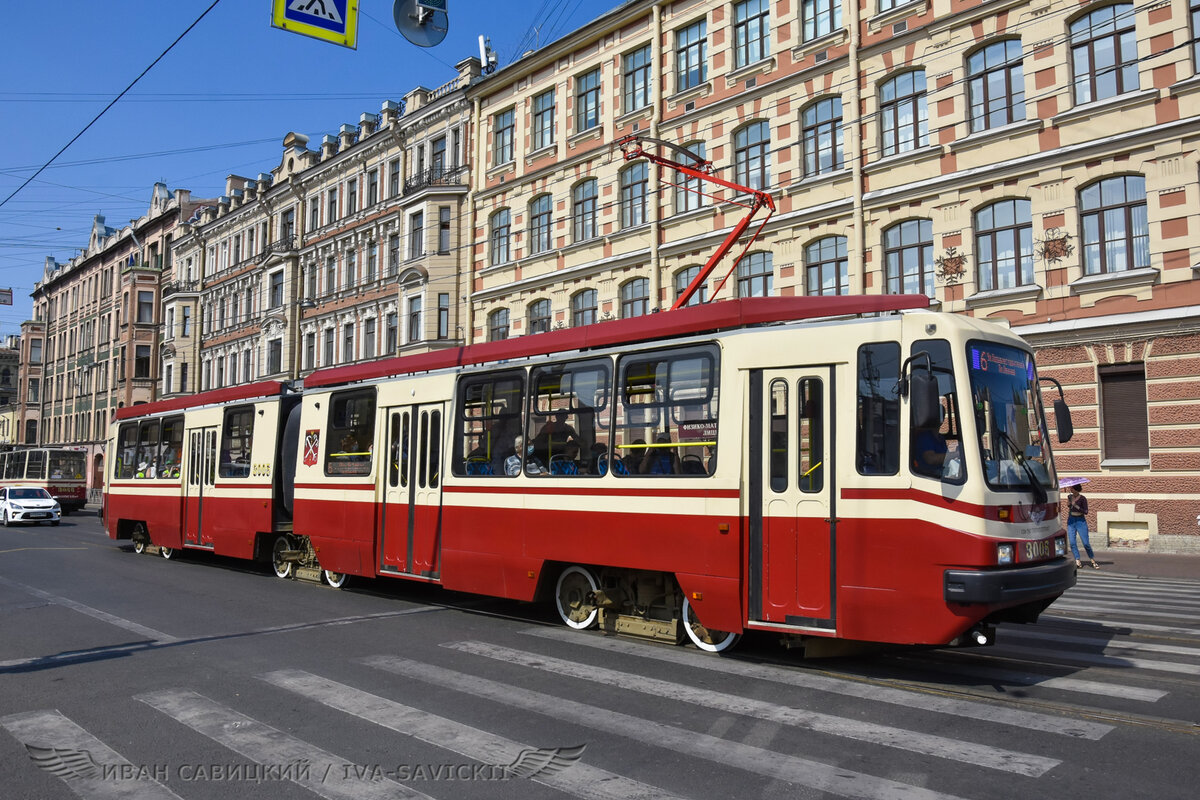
[0,0,620,336]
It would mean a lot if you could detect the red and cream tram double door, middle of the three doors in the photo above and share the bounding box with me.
[379,403,444,578]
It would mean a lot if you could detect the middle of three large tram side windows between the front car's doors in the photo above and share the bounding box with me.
[526,359,612,477]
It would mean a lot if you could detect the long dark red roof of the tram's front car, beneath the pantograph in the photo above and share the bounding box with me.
[304,294,929,389]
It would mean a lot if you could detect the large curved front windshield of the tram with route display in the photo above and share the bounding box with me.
[967,342,1056,497]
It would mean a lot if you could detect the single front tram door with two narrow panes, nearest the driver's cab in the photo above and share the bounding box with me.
[749,366,836,630]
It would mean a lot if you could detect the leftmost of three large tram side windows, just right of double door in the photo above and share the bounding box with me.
[451,371,524,476]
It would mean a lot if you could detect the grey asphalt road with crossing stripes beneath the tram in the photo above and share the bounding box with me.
[0,515,1200,800]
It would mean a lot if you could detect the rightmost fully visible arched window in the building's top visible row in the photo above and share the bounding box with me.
[1070,2,1138,104]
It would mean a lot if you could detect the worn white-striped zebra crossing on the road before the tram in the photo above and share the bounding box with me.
[0,575,1200,800]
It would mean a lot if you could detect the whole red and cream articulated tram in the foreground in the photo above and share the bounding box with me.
[104,295,1075,650]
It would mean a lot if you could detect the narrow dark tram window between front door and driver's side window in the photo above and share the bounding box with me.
[854,342,900,475]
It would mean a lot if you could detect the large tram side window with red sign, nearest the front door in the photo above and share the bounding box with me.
[612,345,720,477]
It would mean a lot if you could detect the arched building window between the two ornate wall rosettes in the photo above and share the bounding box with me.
[974,200,1033,291]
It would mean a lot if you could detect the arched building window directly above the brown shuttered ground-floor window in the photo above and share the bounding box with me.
[1079,175,1150,275]
